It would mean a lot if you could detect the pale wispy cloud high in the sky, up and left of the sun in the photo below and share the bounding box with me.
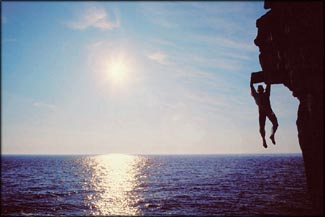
[67,7,120,30]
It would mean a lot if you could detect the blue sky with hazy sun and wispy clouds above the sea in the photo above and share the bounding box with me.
[1,1,301,154]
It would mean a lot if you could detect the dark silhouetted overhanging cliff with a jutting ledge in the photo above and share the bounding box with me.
[253,0,324,215]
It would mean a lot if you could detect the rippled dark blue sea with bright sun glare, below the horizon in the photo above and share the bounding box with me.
[1,154,311,216]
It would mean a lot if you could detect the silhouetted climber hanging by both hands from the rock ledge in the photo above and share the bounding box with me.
[250,77,279,148]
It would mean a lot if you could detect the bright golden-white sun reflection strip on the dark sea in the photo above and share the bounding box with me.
[84,154,145,215]
